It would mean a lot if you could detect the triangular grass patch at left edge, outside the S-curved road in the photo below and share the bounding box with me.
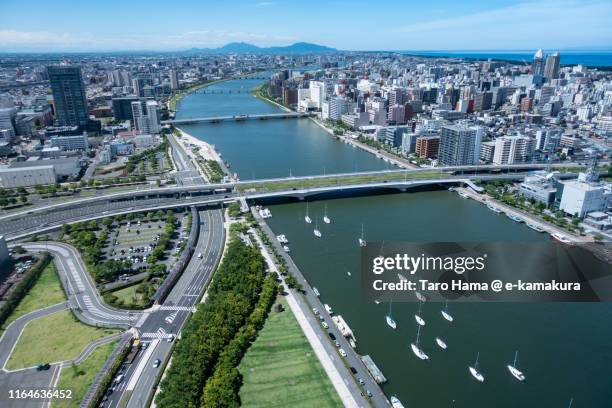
[1,262,66,330]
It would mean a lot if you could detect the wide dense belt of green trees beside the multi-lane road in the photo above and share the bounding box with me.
[156,238,264,408]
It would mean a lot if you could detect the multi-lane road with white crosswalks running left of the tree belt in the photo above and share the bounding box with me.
[105,209,225,408]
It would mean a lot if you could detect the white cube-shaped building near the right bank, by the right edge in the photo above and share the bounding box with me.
[559,180,606,218]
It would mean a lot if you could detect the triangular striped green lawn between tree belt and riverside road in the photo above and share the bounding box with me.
[239,297,342,408]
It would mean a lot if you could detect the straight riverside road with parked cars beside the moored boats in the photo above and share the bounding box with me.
[253,211,389,407]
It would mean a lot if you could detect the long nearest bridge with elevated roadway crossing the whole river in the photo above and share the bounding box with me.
[0,167,575,240]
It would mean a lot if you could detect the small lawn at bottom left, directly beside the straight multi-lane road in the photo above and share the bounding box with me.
[53,341,117,408]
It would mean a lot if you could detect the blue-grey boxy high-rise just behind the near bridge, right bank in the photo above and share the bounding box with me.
[438,125,483,166]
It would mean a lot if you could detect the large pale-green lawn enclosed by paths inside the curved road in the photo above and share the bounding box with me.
[6,310,117,370]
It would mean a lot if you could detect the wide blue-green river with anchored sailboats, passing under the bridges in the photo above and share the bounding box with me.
[178,75,612,408]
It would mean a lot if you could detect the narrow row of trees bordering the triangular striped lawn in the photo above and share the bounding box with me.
[201,274,278,408]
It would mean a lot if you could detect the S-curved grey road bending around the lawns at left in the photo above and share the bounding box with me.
[21,242,142,329]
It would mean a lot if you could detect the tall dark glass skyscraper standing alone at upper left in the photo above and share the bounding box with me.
[47,65,89,127]
